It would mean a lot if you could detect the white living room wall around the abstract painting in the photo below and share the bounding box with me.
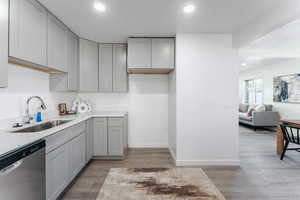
[240,59,300,119]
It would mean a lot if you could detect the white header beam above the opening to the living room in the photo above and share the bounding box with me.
[233,0,300,48]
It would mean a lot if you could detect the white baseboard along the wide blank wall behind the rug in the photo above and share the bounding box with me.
[176,160,241,166]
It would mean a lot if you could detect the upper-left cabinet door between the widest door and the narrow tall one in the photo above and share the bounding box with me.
[48,14,68,72]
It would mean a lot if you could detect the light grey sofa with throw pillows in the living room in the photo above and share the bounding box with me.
[239,104,279,131]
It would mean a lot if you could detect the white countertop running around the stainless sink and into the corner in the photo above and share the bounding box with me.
[0,111,127,156]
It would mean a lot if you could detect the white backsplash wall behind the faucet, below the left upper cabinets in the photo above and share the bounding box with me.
[0,64,76,126]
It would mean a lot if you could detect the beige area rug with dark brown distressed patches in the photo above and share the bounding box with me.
[97,168,225,200]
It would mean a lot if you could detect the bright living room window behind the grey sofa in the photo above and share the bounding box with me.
[242,79,264,105]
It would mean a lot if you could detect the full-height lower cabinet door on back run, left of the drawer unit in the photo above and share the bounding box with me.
[93,118,107,156]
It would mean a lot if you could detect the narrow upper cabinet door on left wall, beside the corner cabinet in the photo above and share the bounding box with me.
[67,31,79,91]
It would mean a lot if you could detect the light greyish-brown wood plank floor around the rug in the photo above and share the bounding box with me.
[62,127,300,200]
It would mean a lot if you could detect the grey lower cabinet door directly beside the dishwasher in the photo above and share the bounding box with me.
[46,145,69,200]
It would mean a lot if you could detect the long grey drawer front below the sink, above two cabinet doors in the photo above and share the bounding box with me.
[46,122,86,153]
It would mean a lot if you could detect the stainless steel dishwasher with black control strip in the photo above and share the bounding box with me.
[0,141,46,200]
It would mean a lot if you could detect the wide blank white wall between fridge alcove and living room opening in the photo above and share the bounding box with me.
[176,34,239,165]
